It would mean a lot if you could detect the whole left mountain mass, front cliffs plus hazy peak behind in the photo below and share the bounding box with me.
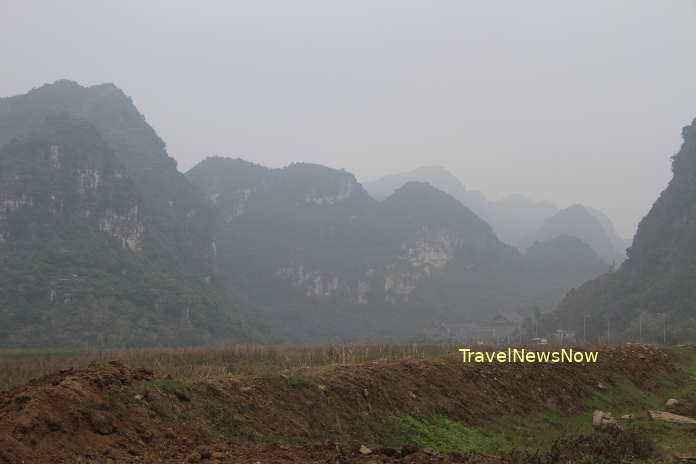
[0,81,262,347]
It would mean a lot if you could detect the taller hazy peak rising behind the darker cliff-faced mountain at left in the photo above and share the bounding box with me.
[0,80,214,270]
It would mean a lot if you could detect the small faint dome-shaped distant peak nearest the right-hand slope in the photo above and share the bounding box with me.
[520,205,623,263]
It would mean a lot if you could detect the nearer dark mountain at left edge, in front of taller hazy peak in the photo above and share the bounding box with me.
[0,113,256,346]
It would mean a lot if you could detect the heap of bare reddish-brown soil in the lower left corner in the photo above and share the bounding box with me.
[0,361,226,464]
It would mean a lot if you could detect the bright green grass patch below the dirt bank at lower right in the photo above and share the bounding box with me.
[384,358,696,456]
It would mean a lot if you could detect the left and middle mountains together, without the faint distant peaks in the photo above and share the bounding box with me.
[0,81,608,347]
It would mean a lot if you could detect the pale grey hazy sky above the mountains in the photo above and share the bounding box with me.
[0,0,696,236]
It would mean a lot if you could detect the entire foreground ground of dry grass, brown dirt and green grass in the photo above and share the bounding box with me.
[0,345,696,464]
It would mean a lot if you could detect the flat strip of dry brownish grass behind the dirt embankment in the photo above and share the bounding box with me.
[0,344,460,391]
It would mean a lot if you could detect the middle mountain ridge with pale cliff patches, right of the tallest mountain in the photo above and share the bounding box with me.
[186,157,608,342]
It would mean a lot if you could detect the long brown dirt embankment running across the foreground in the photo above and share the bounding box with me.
[0,345,675,464]
